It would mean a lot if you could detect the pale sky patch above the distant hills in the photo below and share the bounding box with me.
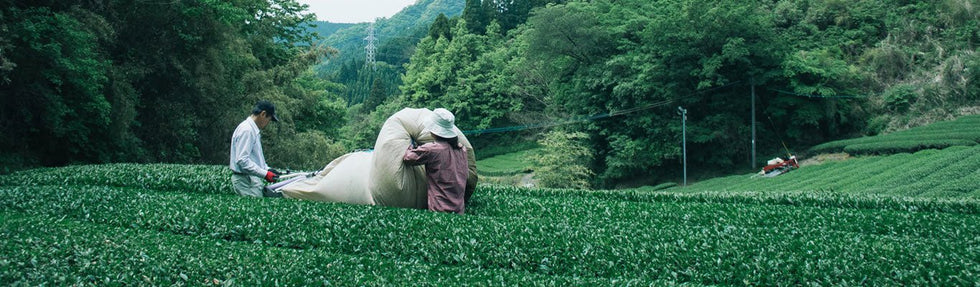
[297,0,415,23]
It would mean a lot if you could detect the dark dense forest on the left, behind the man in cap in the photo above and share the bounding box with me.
[0,0,345,172]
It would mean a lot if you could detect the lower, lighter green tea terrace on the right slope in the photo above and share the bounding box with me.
[670,146,980,200]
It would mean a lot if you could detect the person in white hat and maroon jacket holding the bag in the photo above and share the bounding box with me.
[402,108,469,214]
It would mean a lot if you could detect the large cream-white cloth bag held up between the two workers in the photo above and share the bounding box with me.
[279,109,478,208]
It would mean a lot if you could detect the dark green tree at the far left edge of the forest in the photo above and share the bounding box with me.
[0,7,111,164]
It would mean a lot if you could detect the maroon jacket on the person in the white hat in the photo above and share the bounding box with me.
[402,141,469,214]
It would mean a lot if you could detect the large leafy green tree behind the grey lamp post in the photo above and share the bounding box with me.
[569,1,785,183]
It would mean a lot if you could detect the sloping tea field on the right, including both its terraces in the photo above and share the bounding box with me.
[671,115,980,201]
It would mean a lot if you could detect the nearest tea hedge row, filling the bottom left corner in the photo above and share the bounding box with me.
[0,214,652,286]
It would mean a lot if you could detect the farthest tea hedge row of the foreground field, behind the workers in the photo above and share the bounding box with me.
[0,164,980,214]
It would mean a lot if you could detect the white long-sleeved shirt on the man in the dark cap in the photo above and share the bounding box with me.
[228,117,269,177]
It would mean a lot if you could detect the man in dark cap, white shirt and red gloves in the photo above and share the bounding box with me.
[228,101,279,197]
